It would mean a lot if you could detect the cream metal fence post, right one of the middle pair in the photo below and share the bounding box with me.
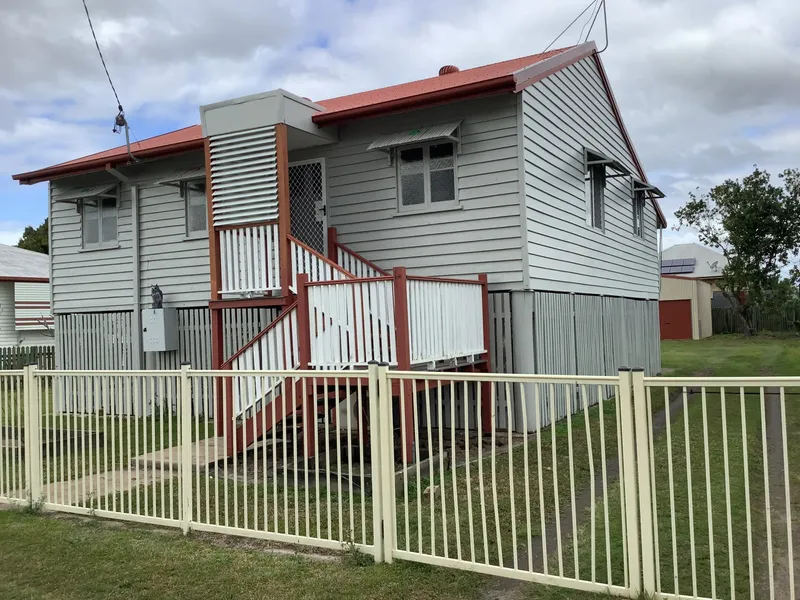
[378,364,396,563]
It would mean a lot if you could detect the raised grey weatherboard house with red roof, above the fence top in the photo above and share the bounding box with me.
[14,43,665,450]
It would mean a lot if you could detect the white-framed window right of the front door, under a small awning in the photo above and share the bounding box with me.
[398,142,458,210]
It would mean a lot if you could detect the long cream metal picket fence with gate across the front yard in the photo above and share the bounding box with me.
[0,365,800,600]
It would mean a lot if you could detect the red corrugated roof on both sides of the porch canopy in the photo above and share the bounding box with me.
[12,48,568,183]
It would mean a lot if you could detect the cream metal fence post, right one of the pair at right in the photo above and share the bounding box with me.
[631,368,656,595]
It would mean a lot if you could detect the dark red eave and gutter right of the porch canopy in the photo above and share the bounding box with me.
[311,74,516,127]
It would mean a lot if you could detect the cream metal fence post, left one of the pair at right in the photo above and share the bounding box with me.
[619,367,642,597]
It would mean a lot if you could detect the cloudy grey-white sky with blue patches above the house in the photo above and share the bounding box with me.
[0,0,800,244]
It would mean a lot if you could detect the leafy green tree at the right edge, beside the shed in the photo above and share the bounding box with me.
[675,167,800,335]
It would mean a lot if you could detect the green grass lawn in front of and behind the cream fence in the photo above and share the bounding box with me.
[0,336,800,600]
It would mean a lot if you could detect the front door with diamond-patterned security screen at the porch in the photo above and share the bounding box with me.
[289,159,328,254]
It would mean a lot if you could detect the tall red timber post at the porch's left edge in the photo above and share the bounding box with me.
[204,138,228,437]
